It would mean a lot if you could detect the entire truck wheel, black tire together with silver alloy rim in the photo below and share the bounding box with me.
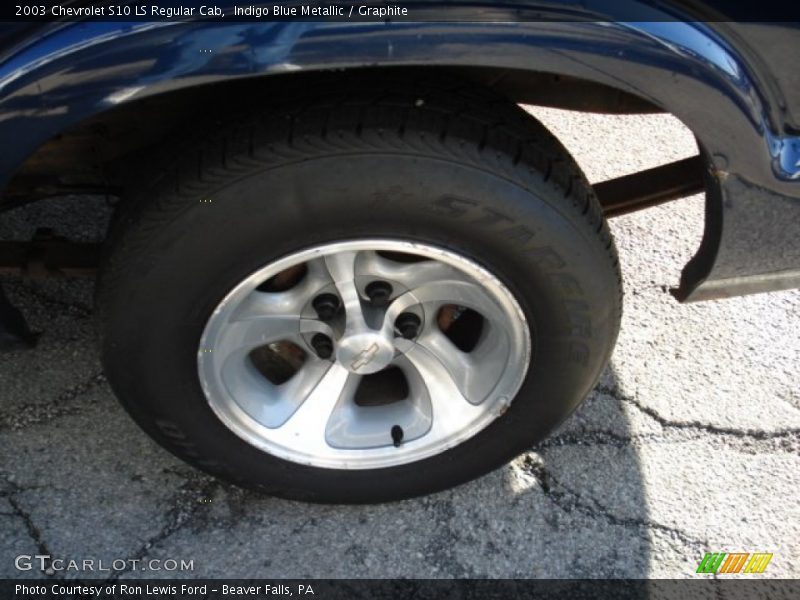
[98,84,621,502]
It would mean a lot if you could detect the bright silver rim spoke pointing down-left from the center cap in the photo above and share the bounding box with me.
[269,363,358,455]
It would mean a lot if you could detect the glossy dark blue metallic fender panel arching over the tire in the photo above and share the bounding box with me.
[0,2,800,299]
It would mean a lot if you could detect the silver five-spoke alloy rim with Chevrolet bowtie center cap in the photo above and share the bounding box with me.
[198,239,531,469]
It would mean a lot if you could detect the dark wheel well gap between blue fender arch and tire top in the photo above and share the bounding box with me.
[2,67,660,208]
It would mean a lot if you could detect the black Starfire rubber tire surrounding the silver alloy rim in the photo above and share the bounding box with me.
[98,82,621,503]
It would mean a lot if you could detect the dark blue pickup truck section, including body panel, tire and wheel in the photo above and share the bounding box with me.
[0,0,800,502]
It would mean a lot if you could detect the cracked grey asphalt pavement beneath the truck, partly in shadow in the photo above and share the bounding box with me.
[0,109,800,578]
